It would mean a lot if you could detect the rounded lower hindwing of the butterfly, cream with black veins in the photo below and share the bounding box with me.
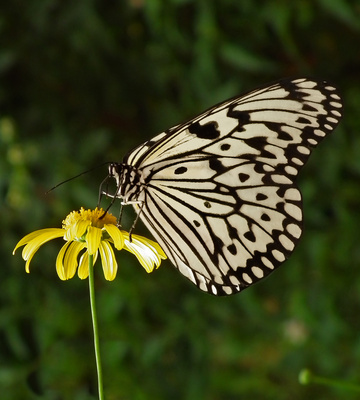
[134,156,302,294]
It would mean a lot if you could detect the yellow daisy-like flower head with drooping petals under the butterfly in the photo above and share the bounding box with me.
[13,208,166,281]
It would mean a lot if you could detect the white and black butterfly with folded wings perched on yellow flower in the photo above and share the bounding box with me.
[106,79,342,295]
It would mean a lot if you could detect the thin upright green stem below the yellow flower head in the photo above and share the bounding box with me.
[89,255,105,400]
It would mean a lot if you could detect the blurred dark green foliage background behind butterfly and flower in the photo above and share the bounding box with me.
[0,0,360,400]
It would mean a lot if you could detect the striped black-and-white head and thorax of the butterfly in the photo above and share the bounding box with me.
[109,163,143,204]
